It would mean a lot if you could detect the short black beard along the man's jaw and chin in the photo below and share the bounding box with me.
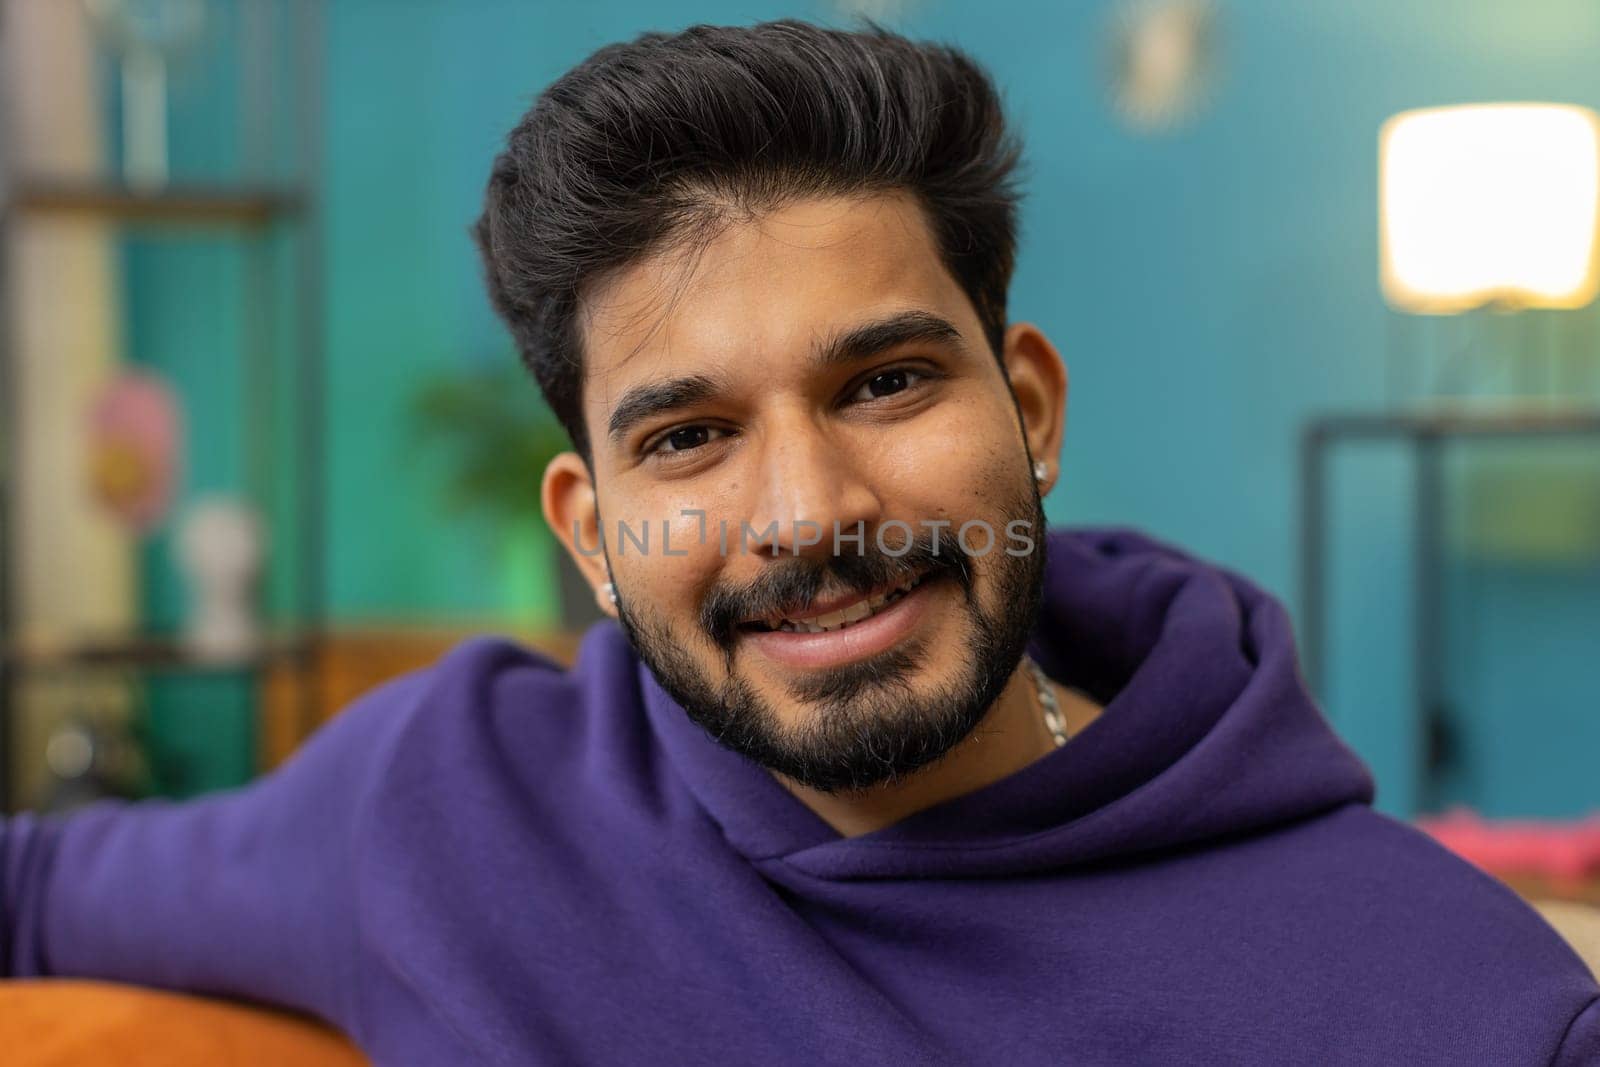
[618,482,1045,793]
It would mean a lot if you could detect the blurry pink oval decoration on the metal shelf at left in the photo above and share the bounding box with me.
[88,371,182,533]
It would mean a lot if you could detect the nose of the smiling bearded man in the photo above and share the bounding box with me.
[746,413,883,555]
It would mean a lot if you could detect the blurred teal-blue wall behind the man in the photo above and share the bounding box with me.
[305,0,1600,814]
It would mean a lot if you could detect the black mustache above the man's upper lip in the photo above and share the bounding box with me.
[699,533,973,653]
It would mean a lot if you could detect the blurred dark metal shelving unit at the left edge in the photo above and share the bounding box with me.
[0,0,325,811]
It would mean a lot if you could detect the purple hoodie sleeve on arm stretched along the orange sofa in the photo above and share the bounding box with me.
[0,672,424,1033]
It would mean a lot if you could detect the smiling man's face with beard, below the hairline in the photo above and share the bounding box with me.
[563,195,1045,792]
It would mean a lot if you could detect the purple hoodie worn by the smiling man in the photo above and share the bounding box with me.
[0,528,1600,1067]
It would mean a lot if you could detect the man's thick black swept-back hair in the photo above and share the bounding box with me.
[472,19,1021,459]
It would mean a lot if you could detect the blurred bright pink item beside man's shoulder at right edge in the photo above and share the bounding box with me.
[1416,808,1600,889]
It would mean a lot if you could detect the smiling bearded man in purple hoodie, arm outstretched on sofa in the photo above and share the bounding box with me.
[3,22,1600,1064]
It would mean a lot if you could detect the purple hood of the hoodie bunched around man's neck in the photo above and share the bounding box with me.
[637,528,1373,880]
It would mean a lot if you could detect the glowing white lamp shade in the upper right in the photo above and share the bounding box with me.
[1379,104,1600,314]
